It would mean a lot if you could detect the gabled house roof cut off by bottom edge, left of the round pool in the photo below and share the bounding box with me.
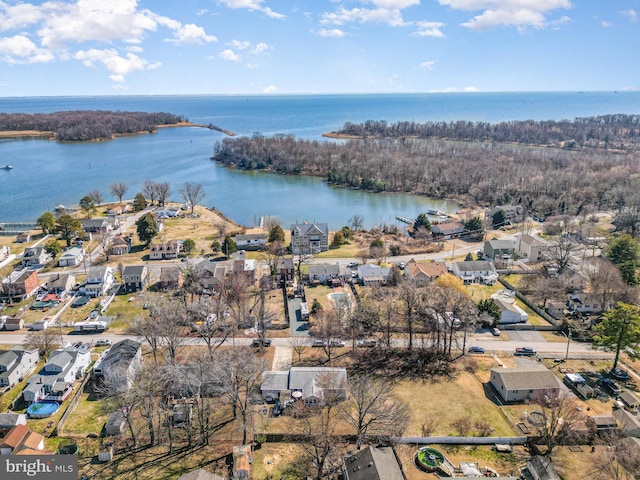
[342,446,404,480]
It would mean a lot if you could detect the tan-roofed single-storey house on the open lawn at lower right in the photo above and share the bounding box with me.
[489,366,566,403]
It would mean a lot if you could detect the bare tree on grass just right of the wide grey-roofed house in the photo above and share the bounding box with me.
[347,375,411,449]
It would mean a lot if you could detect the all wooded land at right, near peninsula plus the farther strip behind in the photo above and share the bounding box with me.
[212,115,640,217]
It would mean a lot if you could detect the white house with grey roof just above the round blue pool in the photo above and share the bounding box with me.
[22,347,91,404]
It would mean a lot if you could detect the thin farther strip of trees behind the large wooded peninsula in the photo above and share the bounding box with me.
[331,114,640,150]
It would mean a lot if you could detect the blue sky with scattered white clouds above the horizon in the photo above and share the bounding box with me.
[0,0,640,97]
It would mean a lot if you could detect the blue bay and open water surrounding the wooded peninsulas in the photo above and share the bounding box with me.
[0,92,640,228]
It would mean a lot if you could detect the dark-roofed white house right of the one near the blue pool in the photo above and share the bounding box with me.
[93,339,142,391]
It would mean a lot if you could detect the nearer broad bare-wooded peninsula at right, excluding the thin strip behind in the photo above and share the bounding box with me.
[212,129,640,216]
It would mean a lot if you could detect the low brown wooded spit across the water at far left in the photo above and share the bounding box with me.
[0,110,186,142]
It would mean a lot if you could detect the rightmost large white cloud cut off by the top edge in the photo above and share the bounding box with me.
[438,0,571,31]
